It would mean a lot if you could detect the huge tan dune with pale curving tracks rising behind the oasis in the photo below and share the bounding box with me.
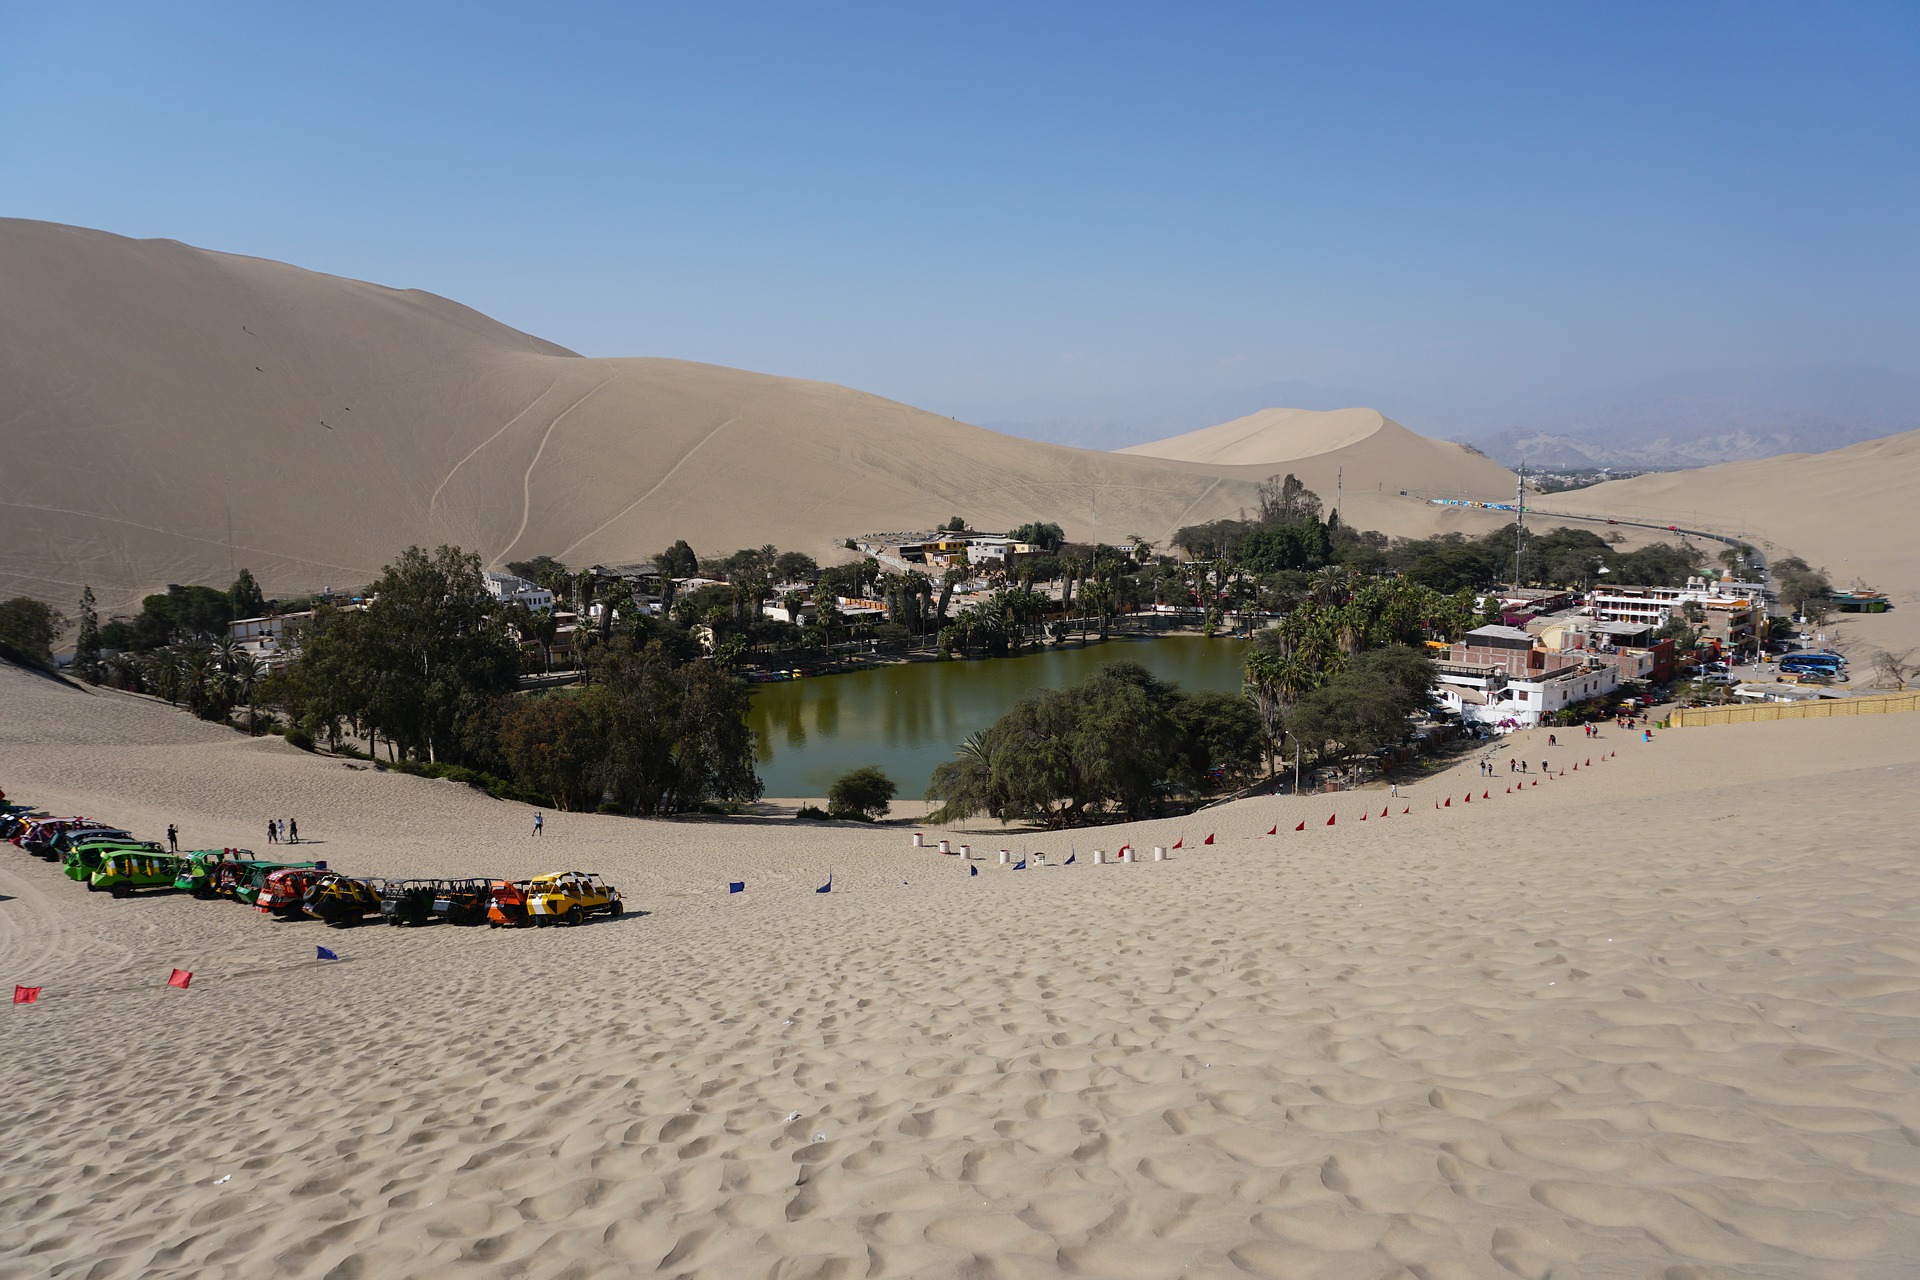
[0,219,1509,614]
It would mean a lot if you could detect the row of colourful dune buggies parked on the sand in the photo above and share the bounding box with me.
[0,804,626,929]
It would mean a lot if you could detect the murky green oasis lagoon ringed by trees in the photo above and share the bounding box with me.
[749,635,1246,800]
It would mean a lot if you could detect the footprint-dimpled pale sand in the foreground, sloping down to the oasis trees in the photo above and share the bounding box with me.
[0,668,1920,1278]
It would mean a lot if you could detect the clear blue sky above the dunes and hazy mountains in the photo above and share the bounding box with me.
[0,0,1920,441]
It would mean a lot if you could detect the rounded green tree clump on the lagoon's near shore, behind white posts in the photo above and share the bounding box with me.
[927,662,1261,827]
